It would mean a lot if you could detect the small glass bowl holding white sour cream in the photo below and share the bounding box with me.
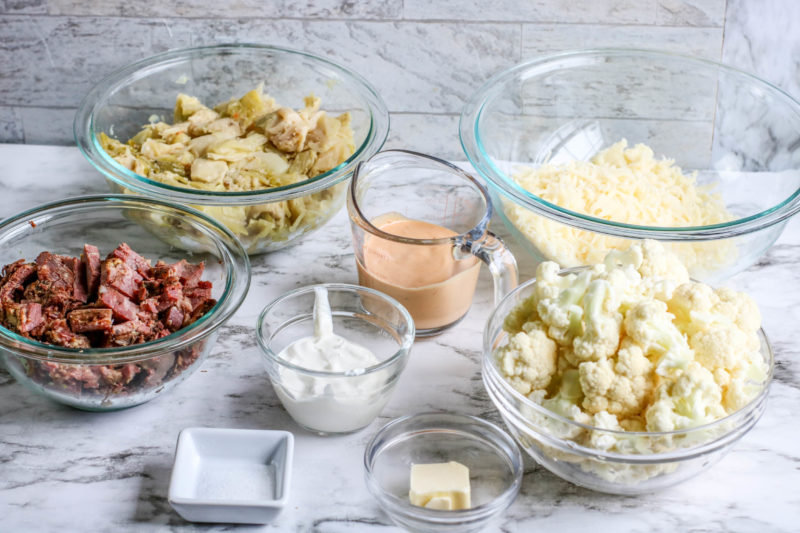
[256,283,414,435]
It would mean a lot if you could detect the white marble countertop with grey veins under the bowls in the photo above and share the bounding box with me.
[0,145,800,533]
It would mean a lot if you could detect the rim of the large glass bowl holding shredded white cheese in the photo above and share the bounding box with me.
[459,48,800,241]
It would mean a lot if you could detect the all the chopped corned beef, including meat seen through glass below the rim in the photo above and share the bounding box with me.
[0,243,216,397]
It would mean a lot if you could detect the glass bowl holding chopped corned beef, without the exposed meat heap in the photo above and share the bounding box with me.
[0,195,250,411]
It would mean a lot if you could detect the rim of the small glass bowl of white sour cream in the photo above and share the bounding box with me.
[256,283,415,378]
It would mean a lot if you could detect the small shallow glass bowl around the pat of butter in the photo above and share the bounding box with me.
[364,413,523,533]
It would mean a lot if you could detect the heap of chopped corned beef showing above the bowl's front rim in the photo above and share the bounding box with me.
[0,243,216,348]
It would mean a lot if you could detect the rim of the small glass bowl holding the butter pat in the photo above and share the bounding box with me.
[364,411,524,524]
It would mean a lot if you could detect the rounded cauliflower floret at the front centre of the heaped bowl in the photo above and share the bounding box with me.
[578,338,653,418]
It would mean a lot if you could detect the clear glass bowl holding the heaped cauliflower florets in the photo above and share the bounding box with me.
[482,269,774,495]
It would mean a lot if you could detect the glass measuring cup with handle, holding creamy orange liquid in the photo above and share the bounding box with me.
[347,150,517,337]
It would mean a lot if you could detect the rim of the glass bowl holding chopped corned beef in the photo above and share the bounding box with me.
[0,194,251,365]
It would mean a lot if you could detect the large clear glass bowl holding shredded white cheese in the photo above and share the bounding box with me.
[460,50,800,282]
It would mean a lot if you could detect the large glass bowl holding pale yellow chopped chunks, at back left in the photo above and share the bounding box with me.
[74,44,389,254]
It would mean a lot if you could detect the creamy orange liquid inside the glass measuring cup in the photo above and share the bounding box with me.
[357,214,480,330]
